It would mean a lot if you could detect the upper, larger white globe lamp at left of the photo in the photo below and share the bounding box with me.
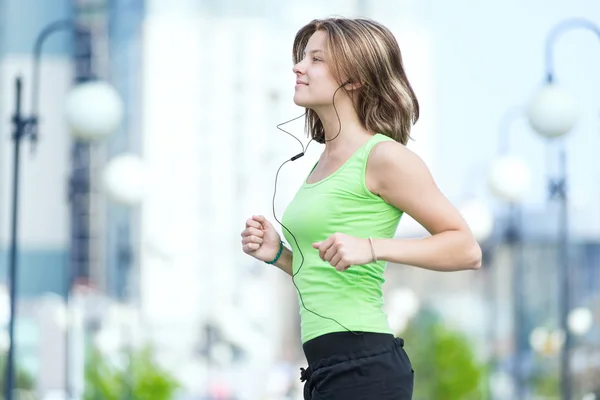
[65,81,124,142]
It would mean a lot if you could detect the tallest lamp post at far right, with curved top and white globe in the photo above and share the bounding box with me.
[527,18,600,400]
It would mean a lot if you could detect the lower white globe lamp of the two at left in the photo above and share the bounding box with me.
[102,153,147,207]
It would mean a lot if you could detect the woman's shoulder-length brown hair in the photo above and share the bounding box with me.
[293,18,419,144]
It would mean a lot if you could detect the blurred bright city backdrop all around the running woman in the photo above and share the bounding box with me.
[0,0,600,400]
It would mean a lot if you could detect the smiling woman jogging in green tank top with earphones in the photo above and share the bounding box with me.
[242,18,481,400]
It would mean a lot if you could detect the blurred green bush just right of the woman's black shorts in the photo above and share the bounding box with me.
[400,310,488,400]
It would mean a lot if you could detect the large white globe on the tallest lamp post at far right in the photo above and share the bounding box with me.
[527,84,577,139]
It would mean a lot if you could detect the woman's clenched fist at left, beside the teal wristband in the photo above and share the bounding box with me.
[242,215,281,262]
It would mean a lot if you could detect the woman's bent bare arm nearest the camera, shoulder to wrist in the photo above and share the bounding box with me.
[366,142,481,271]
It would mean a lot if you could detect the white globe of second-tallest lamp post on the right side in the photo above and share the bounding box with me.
[488,155,532,203]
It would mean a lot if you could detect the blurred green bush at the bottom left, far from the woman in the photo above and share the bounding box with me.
[83,347,179,400]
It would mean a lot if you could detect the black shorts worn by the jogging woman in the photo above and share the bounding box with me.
[300,332,414,400]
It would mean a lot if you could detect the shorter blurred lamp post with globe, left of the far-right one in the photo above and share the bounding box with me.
[488,107,531,400]
